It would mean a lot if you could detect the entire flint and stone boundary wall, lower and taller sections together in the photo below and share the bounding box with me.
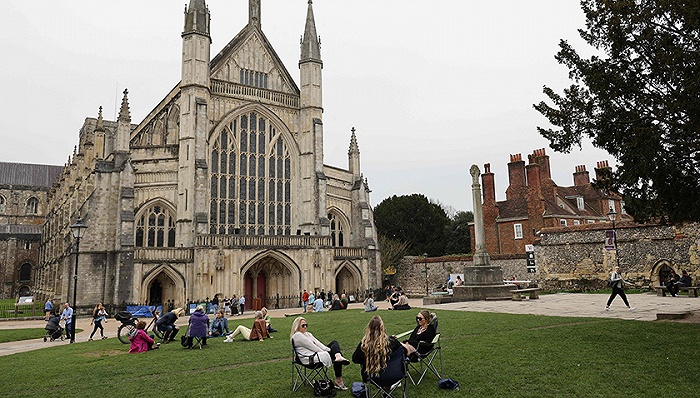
[392,222,700,297]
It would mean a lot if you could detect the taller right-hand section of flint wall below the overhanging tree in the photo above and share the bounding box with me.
[533,223,700,291]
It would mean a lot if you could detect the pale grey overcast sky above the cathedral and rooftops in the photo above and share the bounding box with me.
[0,0,613,210]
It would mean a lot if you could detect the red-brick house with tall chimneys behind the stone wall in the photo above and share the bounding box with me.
[472,149,629,254]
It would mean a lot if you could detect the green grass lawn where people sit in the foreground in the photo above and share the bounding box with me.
[0,310,700,398]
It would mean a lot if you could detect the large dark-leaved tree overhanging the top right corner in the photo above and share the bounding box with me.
[534,0,700,222]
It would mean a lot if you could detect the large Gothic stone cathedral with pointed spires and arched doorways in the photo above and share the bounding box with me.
[33,0,381,307]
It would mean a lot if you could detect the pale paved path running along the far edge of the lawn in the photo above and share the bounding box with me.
[0,293,700,356]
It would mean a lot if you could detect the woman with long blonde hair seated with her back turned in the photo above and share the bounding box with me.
[352,315,403,380]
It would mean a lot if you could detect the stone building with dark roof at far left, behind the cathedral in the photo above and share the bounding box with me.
[0,162,63,299]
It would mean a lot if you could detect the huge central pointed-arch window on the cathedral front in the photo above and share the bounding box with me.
[209,112,292,235]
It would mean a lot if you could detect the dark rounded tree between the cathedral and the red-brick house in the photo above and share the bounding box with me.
[374,194,449,256]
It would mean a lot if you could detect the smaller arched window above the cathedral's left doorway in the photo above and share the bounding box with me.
[136,204,175,247]
